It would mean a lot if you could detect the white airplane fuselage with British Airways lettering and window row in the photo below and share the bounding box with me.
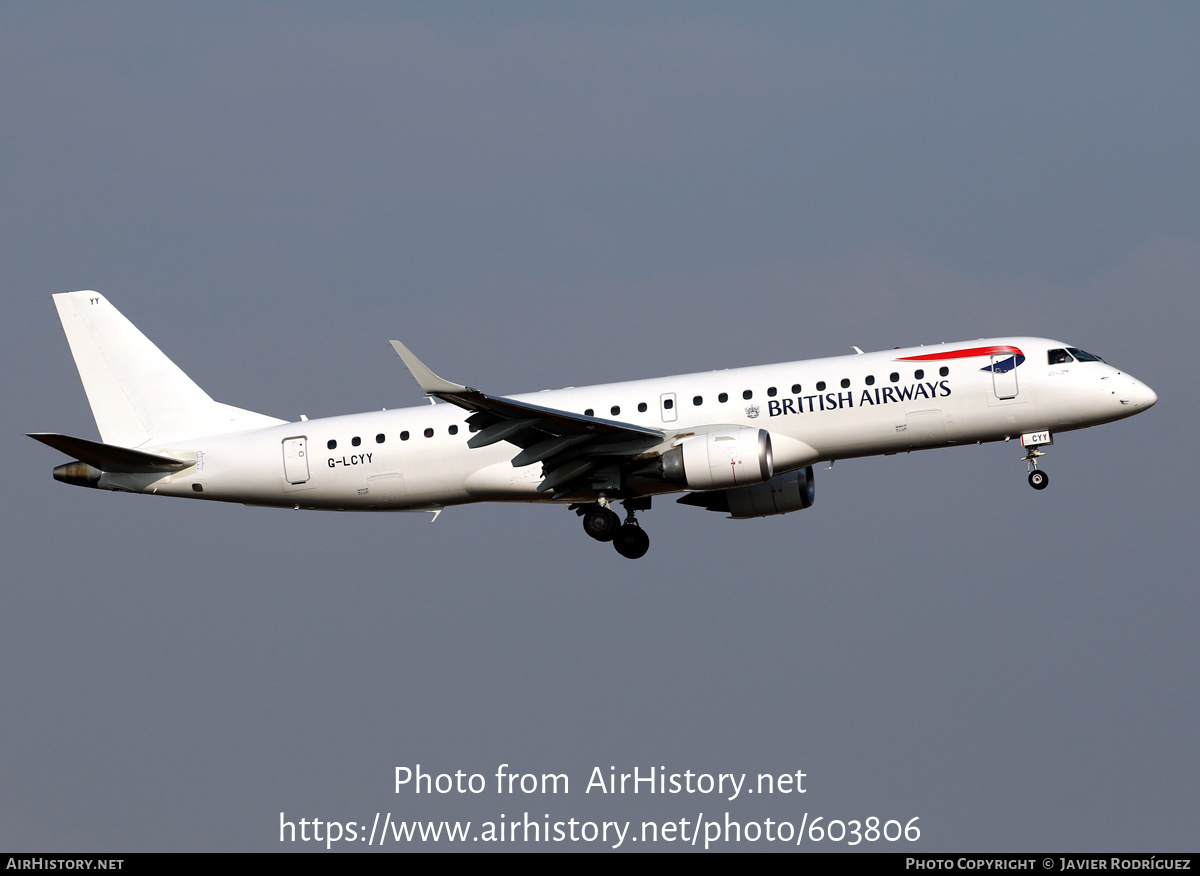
[98,337,1157,510]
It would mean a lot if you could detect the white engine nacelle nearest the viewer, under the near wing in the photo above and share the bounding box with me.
[661,428,775,490]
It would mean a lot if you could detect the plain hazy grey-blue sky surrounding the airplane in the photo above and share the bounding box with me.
[0,2,1200,851]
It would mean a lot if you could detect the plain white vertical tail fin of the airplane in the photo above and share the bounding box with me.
[54,292,286,448]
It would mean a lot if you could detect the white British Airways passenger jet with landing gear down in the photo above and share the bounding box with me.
[30,290,1158,559]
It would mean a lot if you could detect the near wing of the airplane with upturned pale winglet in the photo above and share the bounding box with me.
[391,341,666,496]
